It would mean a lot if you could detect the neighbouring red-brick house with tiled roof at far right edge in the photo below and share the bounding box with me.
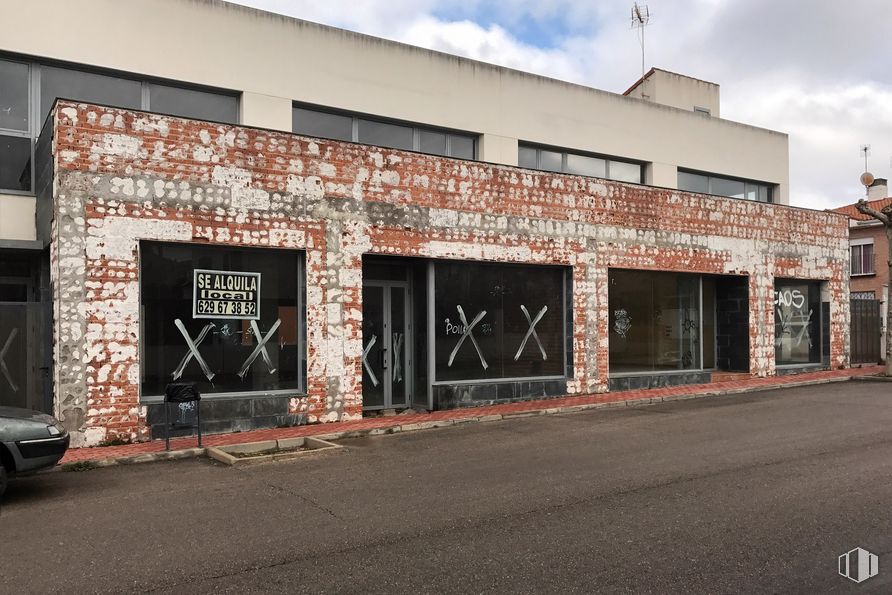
[833,178,892,363]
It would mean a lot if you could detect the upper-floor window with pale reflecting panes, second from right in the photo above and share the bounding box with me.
[517,144,644,184]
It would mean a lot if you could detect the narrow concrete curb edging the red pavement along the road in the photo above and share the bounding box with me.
[53,376,858,471]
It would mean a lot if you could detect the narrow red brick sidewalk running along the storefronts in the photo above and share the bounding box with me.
[61,366,882,464]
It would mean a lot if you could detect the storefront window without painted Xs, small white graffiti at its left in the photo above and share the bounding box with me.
[608,271,701,373]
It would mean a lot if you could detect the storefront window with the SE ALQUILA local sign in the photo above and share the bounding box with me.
[140,242,306,396]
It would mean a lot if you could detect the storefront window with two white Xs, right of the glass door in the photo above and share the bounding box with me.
[434,262,565,381]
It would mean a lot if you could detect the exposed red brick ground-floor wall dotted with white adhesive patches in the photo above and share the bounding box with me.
[52,103,848,445]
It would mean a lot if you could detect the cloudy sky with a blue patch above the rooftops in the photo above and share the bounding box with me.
[230,0,892,209]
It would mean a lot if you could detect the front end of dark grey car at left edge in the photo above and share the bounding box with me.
[0,407,69,496]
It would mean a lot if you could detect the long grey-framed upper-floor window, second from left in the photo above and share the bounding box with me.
[291,106,477,159]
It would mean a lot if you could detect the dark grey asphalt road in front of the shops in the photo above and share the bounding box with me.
[0,382,892,594]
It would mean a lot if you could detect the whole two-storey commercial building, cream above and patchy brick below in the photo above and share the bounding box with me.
[0,0,849,445]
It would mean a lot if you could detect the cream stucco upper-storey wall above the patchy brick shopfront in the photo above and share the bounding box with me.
[0,0,789,239]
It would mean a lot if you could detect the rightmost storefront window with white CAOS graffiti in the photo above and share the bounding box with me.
[774,280,821,366]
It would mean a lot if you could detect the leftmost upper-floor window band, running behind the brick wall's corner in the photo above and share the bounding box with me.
[0,58,238,193]
